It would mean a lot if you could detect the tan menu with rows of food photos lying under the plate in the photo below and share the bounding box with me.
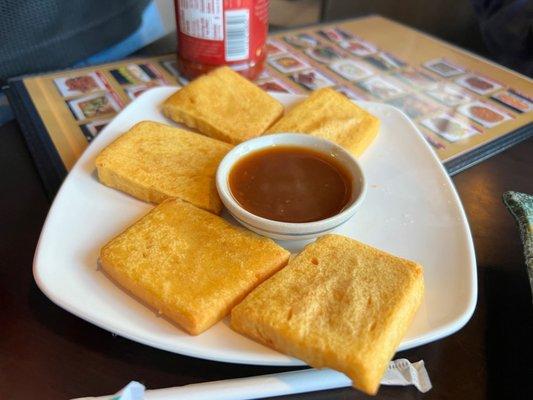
[6,16,533,197]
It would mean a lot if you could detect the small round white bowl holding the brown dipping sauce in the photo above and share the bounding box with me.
[216,133,366,240]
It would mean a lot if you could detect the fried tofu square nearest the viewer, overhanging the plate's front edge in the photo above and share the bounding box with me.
[231,235,424,394]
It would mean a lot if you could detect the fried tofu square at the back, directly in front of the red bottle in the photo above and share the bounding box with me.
[163,67,283,144]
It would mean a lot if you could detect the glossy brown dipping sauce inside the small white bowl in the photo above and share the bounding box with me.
[229,146,354,222]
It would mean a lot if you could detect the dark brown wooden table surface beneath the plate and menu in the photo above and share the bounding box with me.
[0,36,533,400]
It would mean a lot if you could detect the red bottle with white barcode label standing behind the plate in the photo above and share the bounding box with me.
[174,0,268,80]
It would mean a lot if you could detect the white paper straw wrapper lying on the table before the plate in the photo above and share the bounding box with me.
[77,358,431,400]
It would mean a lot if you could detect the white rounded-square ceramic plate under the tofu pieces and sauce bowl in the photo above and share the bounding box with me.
[33,87,477,365]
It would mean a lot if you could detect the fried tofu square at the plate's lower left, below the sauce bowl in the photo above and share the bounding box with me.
[100,199,289,335]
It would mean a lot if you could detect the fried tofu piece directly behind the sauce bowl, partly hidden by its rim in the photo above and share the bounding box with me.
[267,88,380,157]
